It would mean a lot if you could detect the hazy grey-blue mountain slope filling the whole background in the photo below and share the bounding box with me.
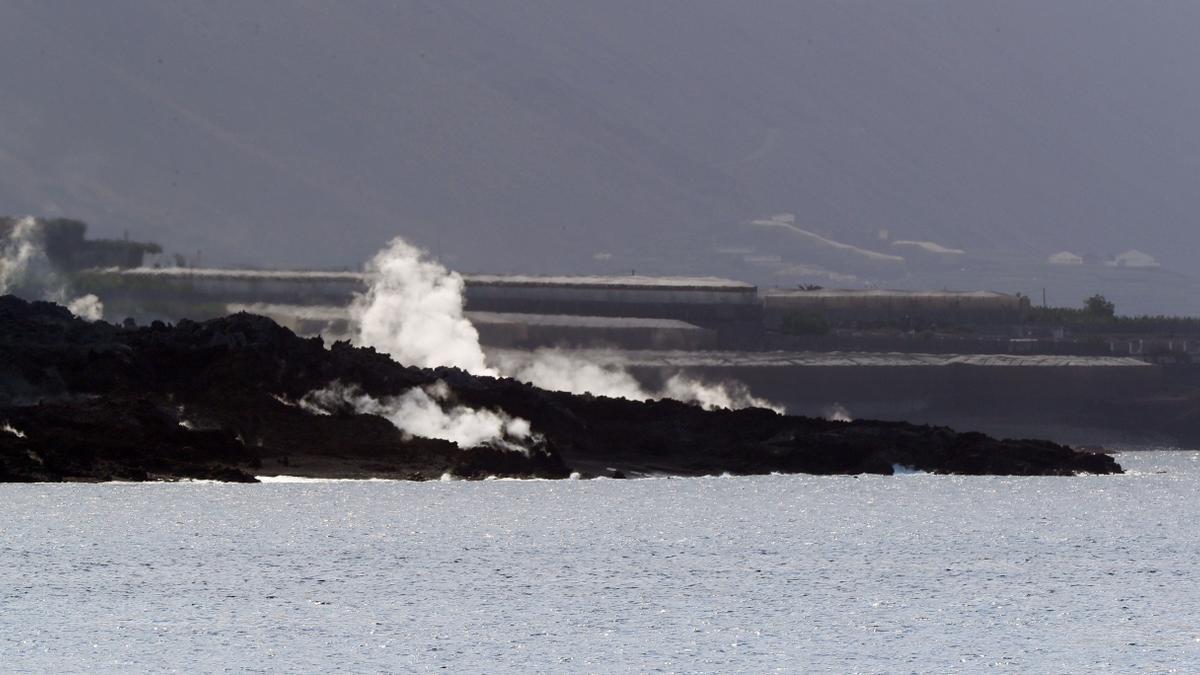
[0,0,1200,305]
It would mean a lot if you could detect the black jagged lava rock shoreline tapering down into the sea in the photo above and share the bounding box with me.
[0,295,1121,482]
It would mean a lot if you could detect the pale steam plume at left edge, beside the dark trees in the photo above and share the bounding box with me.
[0,216,104,321]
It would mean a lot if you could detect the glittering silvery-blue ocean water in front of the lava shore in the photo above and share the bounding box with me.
[0,452,1200,673]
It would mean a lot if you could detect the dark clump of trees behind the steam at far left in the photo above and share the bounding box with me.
[0,216,162,273]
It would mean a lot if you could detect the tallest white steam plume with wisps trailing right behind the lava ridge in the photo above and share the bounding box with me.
[350,238,784,413]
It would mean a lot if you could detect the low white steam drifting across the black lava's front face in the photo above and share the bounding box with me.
[299,381,535,454]
